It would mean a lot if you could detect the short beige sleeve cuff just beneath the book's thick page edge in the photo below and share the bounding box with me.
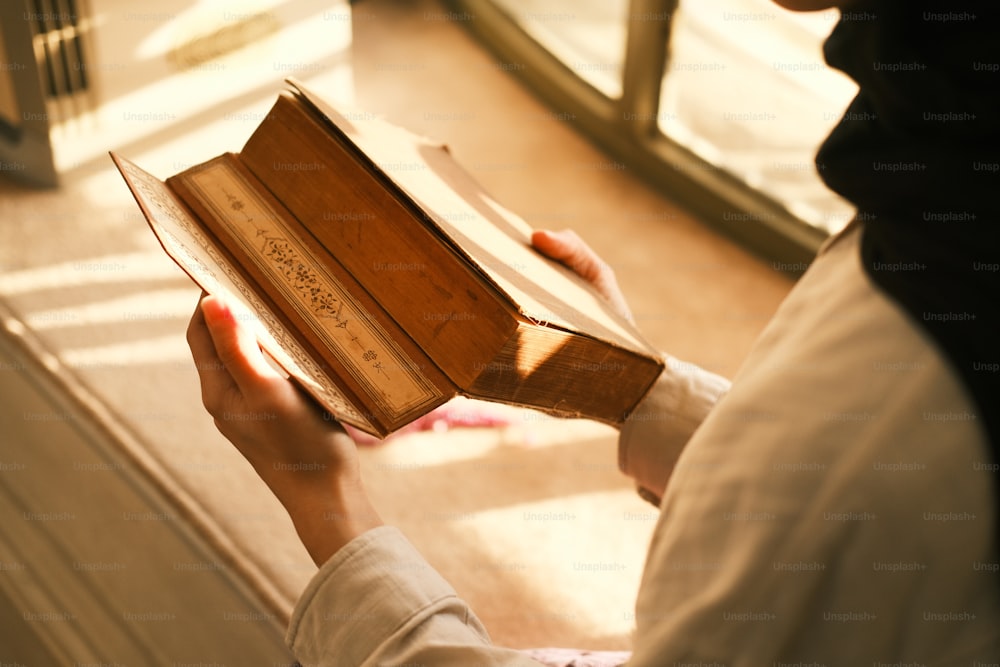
[618,356,730,505]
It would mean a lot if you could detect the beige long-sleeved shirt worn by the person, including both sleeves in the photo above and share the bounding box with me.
[288,228,1000,667]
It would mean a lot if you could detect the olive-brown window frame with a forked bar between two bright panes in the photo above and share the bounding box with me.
[446,0,829,276]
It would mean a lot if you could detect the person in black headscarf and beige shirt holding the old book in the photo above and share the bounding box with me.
[188,0,1000,666]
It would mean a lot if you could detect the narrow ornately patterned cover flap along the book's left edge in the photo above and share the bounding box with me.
[111,153,375,433]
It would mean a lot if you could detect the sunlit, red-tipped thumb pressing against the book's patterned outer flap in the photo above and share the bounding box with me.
[201,296,280,395]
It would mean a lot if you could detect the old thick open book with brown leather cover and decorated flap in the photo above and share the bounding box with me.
[112,81,663,437]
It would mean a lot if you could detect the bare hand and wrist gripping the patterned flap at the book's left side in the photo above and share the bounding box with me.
[187,295,381,565]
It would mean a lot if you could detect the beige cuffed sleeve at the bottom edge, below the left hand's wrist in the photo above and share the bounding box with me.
[286,526,539,667]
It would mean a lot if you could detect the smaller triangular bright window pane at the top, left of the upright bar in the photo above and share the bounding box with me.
[495,0,628,98]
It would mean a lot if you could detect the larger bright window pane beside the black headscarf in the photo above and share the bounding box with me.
[658,0,857,233]
